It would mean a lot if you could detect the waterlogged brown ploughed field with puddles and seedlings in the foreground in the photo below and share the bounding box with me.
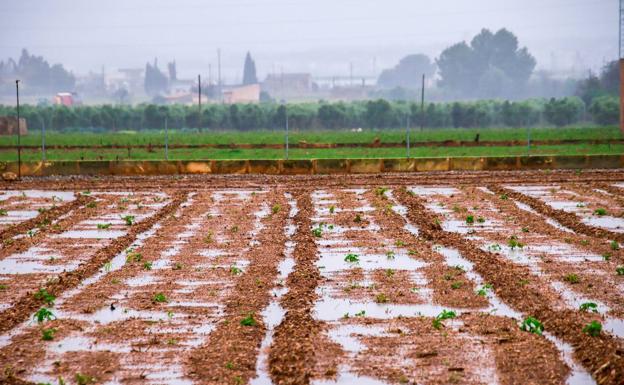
[0,172,624,385]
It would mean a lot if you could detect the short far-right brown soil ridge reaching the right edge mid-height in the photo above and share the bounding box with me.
[488,184,624,242]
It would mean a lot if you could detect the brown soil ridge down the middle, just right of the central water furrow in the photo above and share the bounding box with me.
[268,191,321,385]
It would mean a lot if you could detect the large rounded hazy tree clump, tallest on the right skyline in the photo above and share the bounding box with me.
[436,29,536,97]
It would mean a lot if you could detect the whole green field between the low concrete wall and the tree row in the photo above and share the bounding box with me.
[0,127,624,161]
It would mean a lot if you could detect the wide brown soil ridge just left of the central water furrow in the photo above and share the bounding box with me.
[187,190,289,384]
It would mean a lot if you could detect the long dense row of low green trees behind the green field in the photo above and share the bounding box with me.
[0,95,619,132]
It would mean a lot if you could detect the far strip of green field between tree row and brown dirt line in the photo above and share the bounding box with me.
[0,127,624,147]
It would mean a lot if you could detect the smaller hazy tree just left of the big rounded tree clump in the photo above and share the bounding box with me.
[377,54,436,88]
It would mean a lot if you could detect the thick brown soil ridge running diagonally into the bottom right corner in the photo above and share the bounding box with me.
[395,189,624,385]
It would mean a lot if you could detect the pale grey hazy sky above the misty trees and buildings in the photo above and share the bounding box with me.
[0,0,618,82]
